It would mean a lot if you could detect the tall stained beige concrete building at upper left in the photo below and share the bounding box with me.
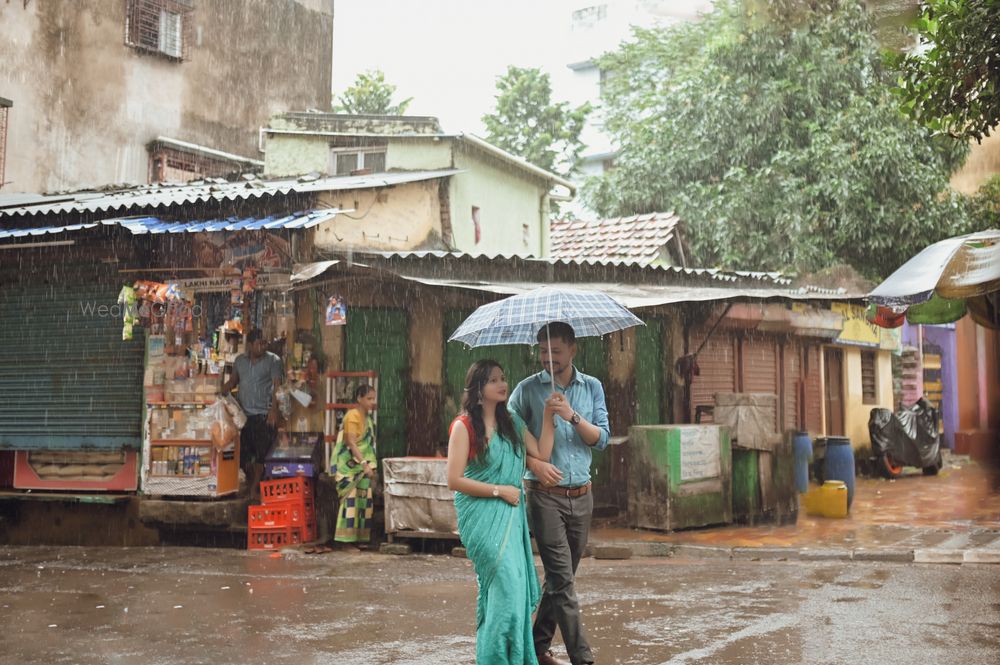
[0,0,333,193]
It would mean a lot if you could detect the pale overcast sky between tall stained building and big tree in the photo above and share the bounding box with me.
[333,0,586,135]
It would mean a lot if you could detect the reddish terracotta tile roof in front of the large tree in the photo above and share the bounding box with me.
[550,212,680,265]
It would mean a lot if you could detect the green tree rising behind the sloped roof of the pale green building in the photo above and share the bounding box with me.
[483,66,591,176]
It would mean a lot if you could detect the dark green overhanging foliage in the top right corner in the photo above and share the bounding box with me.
[899,0,1000,142]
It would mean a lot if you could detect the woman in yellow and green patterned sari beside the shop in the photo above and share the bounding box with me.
[332,384,378,547]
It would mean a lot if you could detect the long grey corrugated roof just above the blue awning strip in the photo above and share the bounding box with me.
[0,169,461,220]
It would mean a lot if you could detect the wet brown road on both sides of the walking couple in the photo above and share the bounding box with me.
[0,547,1000,665]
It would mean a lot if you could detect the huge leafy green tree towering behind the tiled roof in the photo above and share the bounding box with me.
[585,0,967,277]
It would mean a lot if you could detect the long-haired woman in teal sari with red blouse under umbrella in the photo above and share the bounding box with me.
[448,360,555,665]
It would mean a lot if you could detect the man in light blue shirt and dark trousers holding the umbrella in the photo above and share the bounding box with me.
[508,322,611,665]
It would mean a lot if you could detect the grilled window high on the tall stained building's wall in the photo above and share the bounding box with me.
[125,0,194,60]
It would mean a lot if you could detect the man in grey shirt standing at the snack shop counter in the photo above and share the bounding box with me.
[222,328,284,494]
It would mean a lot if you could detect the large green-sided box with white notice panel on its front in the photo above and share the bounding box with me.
[628,425,733,531]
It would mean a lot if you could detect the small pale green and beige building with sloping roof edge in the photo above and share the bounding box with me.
[262,113,573,256]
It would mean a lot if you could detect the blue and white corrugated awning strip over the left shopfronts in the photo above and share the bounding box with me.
[0,208,344,240]
